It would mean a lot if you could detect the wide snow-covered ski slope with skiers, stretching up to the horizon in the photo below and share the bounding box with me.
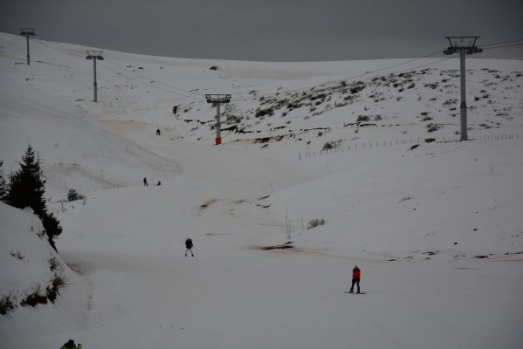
[0,34,523,349]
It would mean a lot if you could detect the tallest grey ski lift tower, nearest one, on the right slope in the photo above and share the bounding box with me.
[443,36,483,141]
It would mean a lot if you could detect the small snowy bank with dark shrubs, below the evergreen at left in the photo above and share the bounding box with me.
[0,202,89,336]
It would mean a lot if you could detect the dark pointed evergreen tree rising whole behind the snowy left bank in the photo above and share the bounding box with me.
[5,145,62,250]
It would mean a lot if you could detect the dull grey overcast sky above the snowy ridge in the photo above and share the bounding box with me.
[0,0,523,62]
